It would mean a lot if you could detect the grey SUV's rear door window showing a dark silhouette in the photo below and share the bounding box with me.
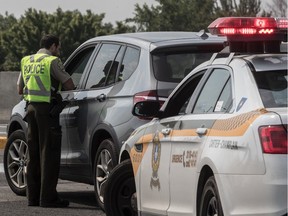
[86,44,124,89]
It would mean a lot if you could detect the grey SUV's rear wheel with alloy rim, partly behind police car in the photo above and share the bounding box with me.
[94,139,118,210]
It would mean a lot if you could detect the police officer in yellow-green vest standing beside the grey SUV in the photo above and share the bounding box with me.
[17,35,74,207]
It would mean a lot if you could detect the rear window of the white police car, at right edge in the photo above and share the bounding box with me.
[254,70,287,108]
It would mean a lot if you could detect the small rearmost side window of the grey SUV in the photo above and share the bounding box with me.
[119,47,140,80]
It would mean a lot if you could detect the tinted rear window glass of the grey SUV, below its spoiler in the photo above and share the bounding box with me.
[152,52,213,83]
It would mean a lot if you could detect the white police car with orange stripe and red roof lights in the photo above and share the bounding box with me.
[105,17,288,216]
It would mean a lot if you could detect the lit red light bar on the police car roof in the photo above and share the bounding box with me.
[208,17,288,36]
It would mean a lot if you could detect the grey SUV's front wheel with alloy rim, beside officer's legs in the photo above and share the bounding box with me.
[4,130,28,196]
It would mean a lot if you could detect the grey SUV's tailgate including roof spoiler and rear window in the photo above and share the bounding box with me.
[151,41,223,98]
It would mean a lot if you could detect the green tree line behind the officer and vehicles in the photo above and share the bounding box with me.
[0,0,287,71]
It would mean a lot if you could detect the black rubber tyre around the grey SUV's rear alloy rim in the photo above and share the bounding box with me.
[94,139,118,210]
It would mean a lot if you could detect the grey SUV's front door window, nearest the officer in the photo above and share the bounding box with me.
[65,46,95,86]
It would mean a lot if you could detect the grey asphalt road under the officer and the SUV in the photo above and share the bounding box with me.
[0,150,105,216]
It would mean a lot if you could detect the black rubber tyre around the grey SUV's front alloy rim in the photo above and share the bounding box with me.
[3,130,28,196]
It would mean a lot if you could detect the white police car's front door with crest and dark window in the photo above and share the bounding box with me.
[140,71,204,215]
